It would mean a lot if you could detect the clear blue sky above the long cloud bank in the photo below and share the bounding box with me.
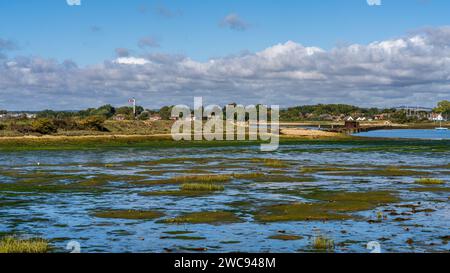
[0,0,450,64]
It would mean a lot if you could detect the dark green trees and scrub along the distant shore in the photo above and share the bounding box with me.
[0,100,450,134]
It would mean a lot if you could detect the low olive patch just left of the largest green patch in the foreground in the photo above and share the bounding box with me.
[161,211,241,225]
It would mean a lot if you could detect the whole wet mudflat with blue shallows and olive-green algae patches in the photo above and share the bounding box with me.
[0,140,450,252]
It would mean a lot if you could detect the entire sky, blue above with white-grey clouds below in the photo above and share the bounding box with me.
[0,0,450,110]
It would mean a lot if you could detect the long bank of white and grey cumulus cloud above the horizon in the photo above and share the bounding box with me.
[0,27,450,109]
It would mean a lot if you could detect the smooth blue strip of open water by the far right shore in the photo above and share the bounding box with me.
[355,129,450,140]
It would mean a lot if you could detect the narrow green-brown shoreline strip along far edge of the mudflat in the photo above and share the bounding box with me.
[0,131,446,152]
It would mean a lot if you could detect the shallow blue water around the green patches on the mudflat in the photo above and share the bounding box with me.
[0,140,450,252]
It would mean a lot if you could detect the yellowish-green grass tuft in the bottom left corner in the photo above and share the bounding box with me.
[0,236,50,253]
